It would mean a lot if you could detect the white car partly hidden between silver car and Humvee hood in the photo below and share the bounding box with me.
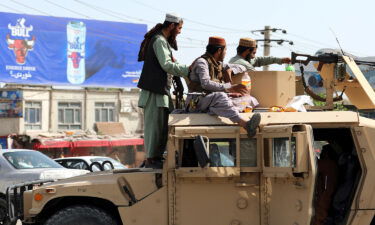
[55,156,128,172]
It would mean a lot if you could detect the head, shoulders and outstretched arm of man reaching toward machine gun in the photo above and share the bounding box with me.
[229,38,291,71]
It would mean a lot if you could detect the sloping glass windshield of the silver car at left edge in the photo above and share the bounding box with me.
[3,151,63,169]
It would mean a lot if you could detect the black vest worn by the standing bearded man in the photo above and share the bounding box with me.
[137,33,172,95]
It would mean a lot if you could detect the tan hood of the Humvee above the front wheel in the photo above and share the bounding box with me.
[34,169,161,205]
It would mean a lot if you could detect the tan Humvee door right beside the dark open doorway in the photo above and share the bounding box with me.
[260,125,316,225]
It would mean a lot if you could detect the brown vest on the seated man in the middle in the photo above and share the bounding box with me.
[187,53,223,93]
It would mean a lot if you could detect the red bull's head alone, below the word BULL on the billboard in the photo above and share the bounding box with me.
[7,34,35,65]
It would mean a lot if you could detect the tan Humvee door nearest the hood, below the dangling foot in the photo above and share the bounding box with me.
[170,126,260,225]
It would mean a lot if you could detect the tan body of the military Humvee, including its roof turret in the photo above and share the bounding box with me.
[13,57,375,225]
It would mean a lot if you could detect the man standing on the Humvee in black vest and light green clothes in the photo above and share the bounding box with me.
[138,14,189,169]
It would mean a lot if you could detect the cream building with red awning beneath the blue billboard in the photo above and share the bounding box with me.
[0,86,144,166]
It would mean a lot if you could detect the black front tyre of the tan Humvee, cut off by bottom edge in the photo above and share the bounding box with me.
[44,205,117,225]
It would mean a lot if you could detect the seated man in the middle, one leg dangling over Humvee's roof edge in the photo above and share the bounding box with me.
[187,37,261,137]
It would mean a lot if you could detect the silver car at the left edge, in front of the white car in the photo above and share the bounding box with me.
[0,149,88,224]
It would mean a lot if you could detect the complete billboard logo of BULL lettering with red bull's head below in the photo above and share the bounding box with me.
[6,18,35,65]
